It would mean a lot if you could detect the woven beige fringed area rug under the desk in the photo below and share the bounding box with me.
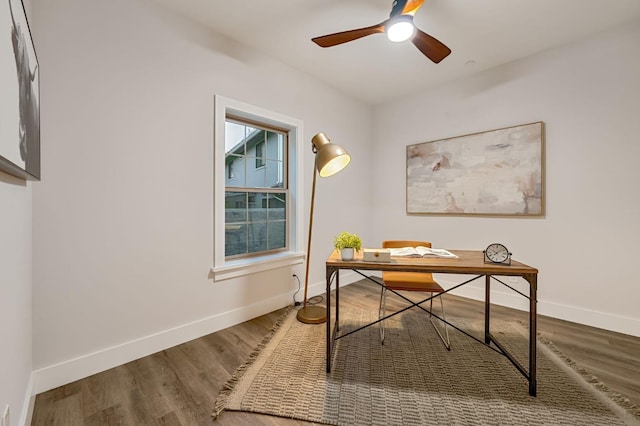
[213,309,640,426]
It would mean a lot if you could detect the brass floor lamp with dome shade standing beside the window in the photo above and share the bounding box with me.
[297,133,351,324]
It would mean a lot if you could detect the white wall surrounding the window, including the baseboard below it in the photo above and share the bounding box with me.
[28,0,371,392]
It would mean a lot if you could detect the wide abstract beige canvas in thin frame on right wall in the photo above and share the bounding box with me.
[407,122,544,216]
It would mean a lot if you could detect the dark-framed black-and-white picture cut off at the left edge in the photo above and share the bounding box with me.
[0,0,40,180]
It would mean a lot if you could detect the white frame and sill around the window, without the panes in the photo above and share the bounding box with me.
[211,95,305,281]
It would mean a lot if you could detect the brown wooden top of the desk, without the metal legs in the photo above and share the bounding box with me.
[326,250,538,276]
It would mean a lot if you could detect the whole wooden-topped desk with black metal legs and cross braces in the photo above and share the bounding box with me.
[326,250,538,396]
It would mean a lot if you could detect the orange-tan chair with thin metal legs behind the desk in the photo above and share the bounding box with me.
[378,240,451,350]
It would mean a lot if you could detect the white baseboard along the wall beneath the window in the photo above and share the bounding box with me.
[32,293,292,395]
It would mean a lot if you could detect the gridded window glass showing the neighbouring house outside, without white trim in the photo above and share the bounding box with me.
[225,116,289,258]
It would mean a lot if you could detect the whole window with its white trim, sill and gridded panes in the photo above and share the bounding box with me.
[212,96,304,280]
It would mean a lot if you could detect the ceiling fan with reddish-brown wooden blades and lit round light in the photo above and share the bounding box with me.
[311,0,451,64]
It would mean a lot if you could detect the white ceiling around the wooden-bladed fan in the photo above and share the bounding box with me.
[154,0,640,104]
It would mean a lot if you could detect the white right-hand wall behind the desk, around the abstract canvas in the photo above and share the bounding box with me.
[372,23,640,336]
